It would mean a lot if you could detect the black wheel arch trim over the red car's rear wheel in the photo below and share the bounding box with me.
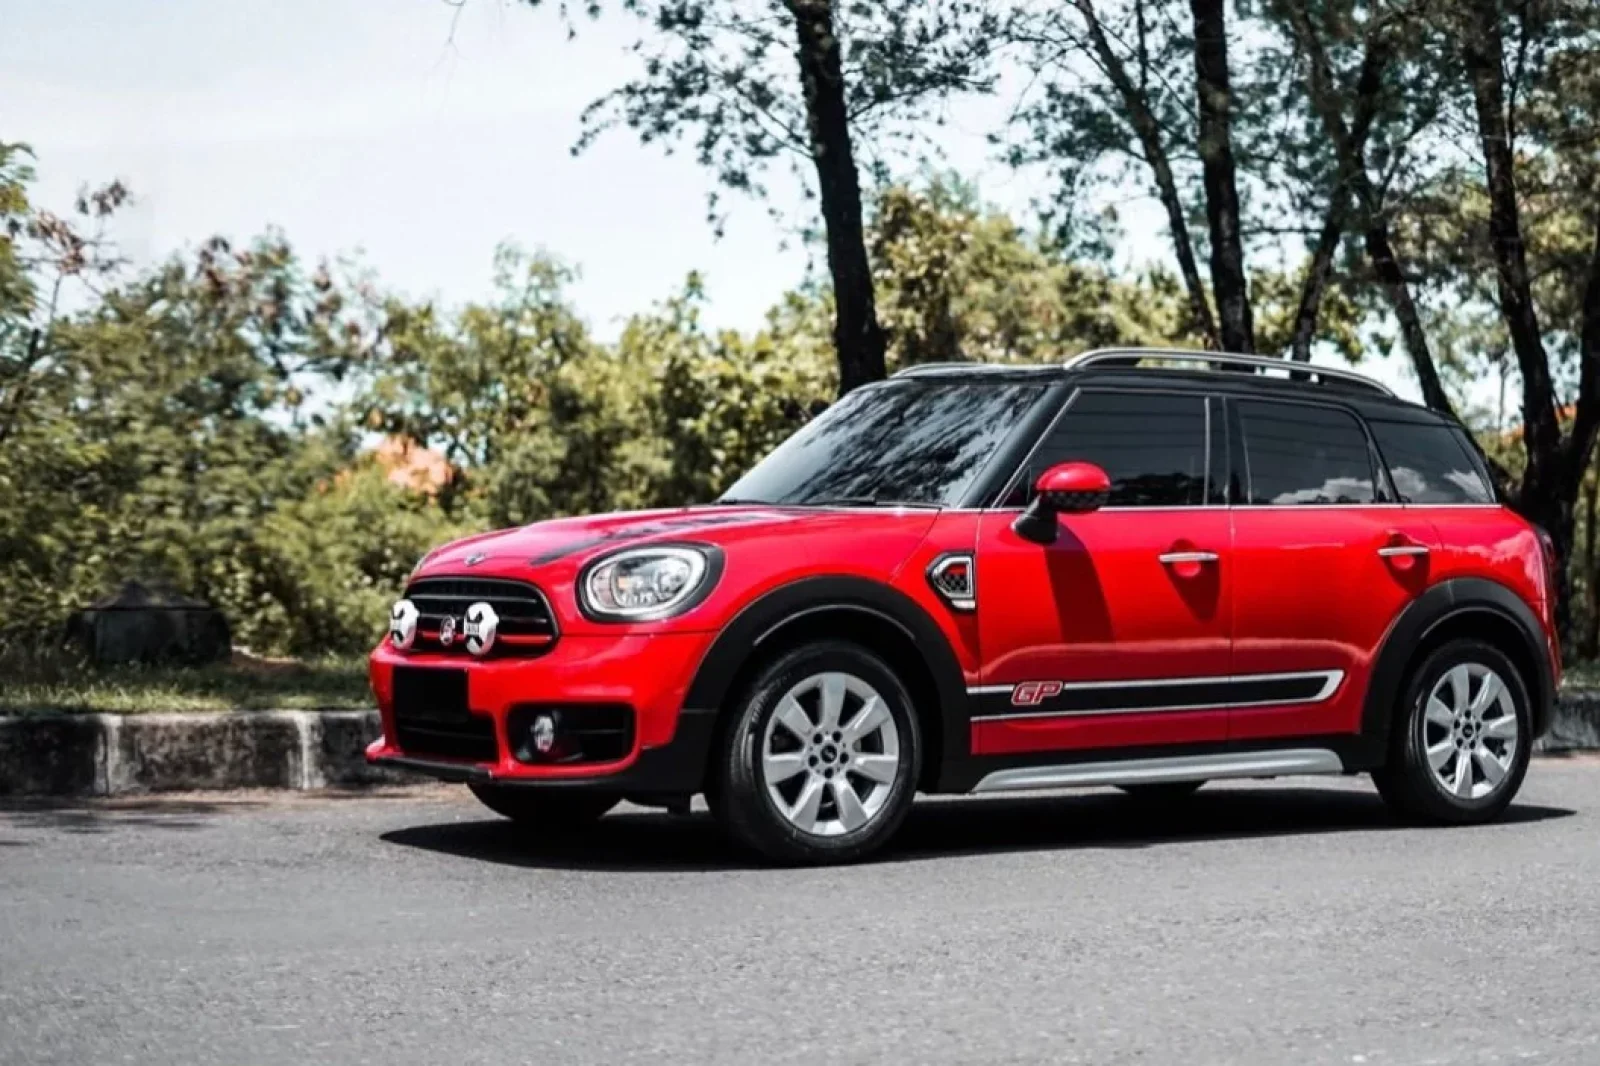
[1362,578,1555,765]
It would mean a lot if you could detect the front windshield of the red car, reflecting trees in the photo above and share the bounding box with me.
[723,378,1046,507]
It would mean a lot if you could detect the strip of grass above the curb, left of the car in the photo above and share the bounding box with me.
[0,640,373,714]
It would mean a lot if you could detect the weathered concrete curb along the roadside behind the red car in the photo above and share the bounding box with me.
[0,690,1600,795]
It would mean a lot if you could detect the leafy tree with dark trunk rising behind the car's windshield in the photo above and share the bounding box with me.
[528,0,1002,394]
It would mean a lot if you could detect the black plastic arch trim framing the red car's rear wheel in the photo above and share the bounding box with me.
[1362,578,1555,751]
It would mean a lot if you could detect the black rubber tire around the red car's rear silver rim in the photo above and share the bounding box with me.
[1373,639,1533,826]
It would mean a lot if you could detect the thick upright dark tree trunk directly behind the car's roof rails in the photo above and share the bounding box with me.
[1189,0,1256,352]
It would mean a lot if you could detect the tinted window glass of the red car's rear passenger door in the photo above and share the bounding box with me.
[1238,400,1373,506]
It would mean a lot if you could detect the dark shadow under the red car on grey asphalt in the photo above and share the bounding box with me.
[382,787,1574,872]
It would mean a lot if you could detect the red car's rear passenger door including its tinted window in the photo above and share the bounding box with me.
[1229,399,1437,739]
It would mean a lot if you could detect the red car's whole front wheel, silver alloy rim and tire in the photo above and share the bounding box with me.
[709,640,922,863]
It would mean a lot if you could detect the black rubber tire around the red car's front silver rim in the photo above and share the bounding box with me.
[707,640,922,864]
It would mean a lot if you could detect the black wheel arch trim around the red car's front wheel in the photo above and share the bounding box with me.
[683,576,970,789]
